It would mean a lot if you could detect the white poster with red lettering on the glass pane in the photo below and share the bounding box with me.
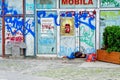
[41,18,54,34]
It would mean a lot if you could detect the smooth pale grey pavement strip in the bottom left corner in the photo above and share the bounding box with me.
[0,70,57,80]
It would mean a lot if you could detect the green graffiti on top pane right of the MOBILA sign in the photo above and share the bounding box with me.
[101,0,120,7]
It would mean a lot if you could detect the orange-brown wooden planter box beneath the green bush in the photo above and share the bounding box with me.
[97,50,120,64]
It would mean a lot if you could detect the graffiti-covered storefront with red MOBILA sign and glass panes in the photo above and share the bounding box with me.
[0,0,120,56]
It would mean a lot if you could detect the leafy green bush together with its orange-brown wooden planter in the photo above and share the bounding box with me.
[97,26,120,64]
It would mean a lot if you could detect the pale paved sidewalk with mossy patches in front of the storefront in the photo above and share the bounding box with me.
[0,58,120,80]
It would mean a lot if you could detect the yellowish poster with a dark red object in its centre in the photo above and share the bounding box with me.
[60,18,74,36]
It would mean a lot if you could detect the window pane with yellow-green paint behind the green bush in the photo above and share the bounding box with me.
[100,10,120,48]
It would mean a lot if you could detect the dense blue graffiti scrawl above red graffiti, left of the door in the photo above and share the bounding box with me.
[5,17,35,37]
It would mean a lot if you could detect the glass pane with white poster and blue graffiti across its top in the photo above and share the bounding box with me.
[37,11,58,54]
